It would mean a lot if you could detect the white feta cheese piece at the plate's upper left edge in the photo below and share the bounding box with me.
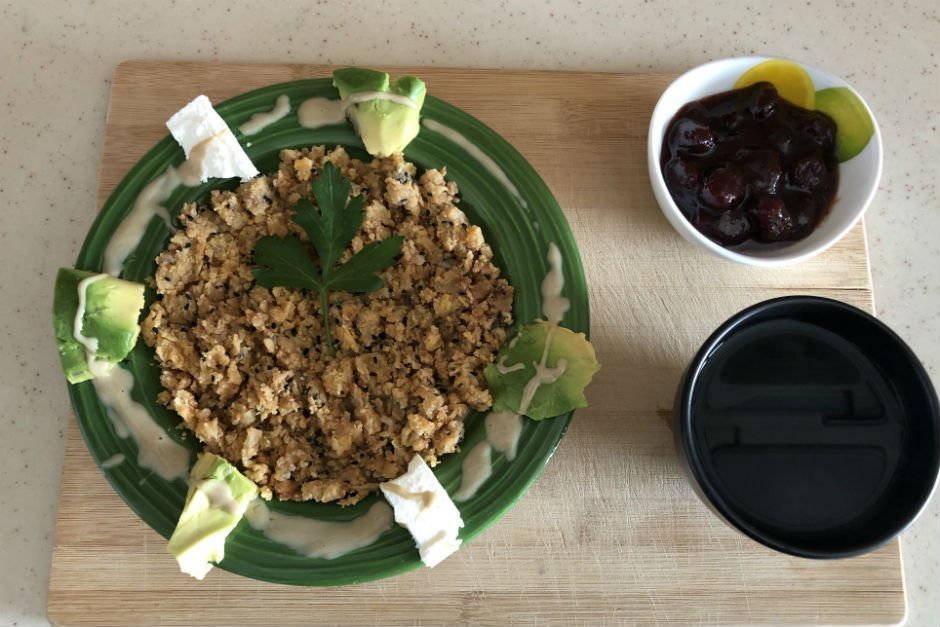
[166,96,258,183]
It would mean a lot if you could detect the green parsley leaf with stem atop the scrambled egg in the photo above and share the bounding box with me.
[251,162,404,355]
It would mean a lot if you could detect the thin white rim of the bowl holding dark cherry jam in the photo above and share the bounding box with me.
[646,55,884,268]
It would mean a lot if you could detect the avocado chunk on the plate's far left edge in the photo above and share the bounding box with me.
[52,268,144,383]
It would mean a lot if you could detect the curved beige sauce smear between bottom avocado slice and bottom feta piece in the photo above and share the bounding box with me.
[245,499,393,559]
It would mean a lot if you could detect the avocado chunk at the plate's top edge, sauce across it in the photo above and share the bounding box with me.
[333,68,427,157]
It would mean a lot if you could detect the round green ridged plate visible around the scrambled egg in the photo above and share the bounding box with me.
[70,79,588,586]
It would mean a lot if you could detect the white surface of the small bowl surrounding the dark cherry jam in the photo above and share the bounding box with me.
[647,57,883,267]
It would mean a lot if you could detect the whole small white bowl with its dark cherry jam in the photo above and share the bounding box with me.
[648,57,882,266]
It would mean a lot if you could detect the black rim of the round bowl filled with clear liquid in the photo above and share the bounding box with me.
[677,296,940,559]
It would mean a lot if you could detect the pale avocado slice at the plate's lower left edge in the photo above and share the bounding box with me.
[167,453,258,579]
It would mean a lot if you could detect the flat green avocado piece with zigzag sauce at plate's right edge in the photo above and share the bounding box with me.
[483,320,601,420]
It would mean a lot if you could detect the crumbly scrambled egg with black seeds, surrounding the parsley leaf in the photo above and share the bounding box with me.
[142,146,513,505]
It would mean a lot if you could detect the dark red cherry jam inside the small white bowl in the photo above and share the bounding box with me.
[660,83,839,246]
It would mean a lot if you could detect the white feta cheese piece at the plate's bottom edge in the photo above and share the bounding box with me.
[379,455,463,568]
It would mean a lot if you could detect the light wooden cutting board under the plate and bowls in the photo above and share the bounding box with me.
[48,62,905,627]
